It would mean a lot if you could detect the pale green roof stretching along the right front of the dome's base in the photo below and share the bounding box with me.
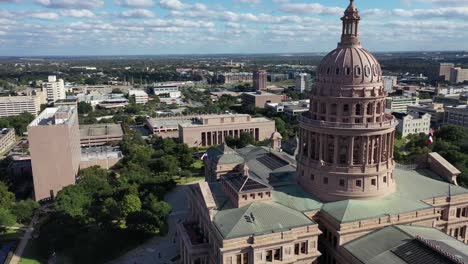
[322,168,468,223]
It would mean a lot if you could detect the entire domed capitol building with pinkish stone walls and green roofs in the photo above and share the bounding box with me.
[177,0,468,264]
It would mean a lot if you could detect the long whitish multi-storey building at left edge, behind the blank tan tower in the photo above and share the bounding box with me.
[0,91,42,117]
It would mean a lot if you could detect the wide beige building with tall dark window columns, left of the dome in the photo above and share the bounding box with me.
[178,114,275,147]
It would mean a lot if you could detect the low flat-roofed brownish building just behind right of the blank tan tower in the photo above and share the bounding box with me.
[80,124,124,147]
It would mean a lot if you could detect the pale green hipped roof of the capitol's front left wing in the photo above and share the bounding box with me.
[213,202,315,239]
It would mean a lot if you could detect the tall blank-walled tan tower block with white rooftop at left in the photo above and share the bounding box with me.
[28,107,81,201]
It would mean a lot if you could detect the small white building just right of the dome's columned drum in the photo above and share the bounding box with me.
[394,112,431,138]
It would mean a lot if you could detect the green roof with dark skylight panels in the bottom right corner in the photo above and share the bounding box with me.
[343,225,468,264]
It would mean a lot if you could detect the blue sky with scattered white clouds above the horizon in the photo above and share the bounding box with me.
[0,0,468,56]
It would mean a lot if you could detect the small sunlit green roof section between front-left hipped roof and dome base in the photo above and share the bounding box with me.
[273,185,322,212]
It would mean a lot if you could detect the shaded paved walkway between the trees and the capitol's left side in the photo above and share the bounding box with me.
[111,182,199,264]
